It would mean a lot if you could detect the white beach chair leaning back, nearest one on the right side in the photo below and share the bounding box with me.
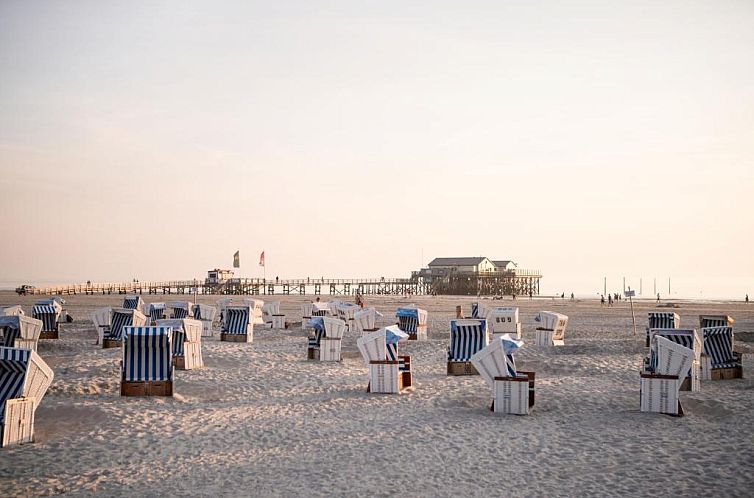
[639,329,696,417]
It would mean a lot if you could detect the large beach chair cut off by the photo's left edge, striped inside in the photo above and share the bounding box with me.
[0,346,54,446]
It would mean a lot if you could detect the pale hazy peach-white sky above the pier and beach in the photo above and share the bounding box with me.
[0,0,754,298]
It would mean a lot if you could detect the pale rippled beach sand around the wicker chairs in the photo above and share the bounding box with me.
[0,292,754,496]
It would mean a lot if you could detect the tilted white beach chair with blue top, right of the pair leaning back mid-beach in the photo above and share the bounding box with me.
[471,334,536,415]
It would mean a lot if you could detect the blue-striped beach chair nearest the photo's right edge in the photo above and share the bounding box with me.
[701,326,743,380]
